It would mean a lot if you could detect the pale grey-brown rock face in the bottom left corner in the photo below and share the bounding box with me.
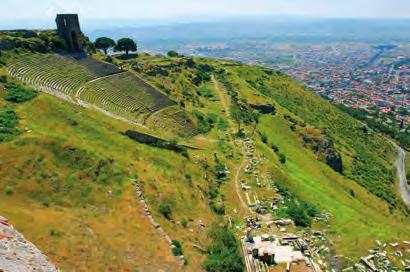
[0,216,58,272]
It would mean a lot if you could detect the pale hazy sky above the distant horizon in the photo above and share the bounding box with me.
[0,0,410,24]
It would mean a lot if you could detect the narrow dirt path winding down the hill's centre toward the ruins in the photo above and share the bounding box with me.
[212,75,253,213]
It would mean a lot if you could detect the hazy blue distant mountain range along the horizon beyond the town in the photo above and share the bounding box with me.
[85,17,410,47]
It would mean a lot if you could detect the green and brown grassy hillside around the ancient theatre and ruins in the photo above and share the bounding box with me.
[0,50,410,271]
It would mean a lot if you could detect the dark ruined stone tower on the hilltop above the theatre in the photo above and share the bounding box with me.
[56,14,83,53]
